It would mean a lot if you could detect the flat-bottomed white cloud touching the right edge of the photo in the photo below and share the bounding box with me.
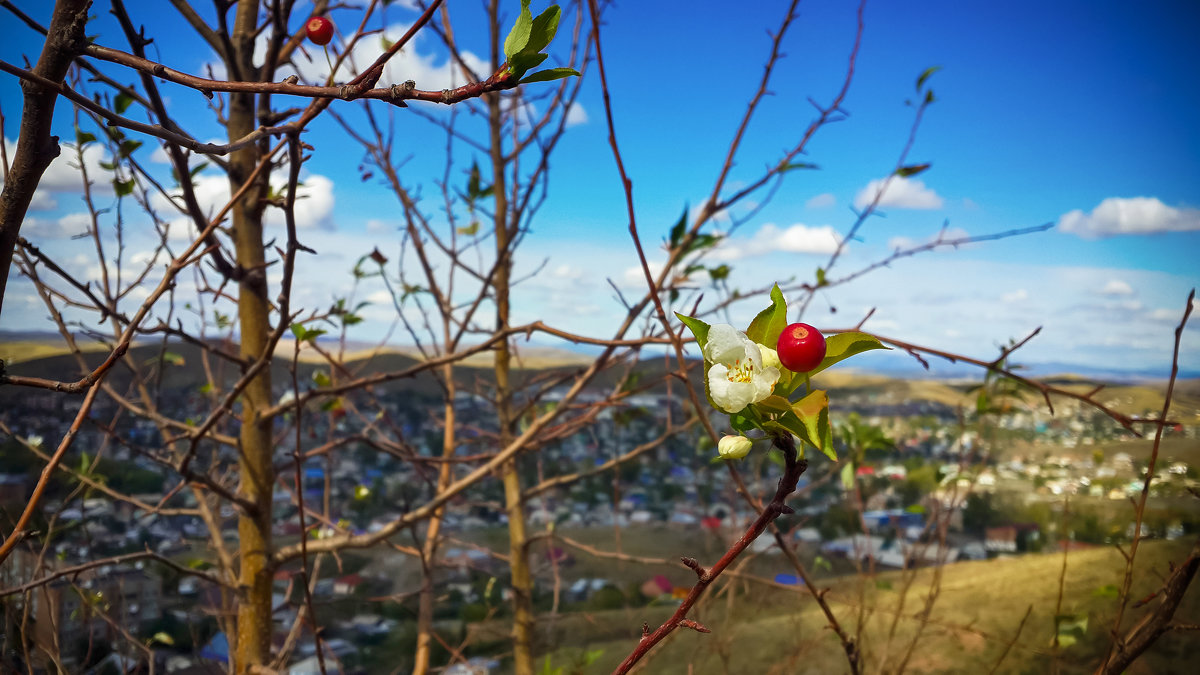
[1058,197,1200,239]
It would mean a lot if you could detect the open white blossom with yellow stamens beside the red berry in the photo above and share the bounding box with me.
[704,323,779,413]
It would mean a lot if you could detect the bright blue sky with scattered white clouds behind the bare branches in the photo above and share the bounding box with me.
[0,0,1200,374]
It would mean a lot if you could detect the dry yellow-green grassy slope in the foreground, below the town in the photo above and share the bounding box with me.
[544,542,1200,675]
